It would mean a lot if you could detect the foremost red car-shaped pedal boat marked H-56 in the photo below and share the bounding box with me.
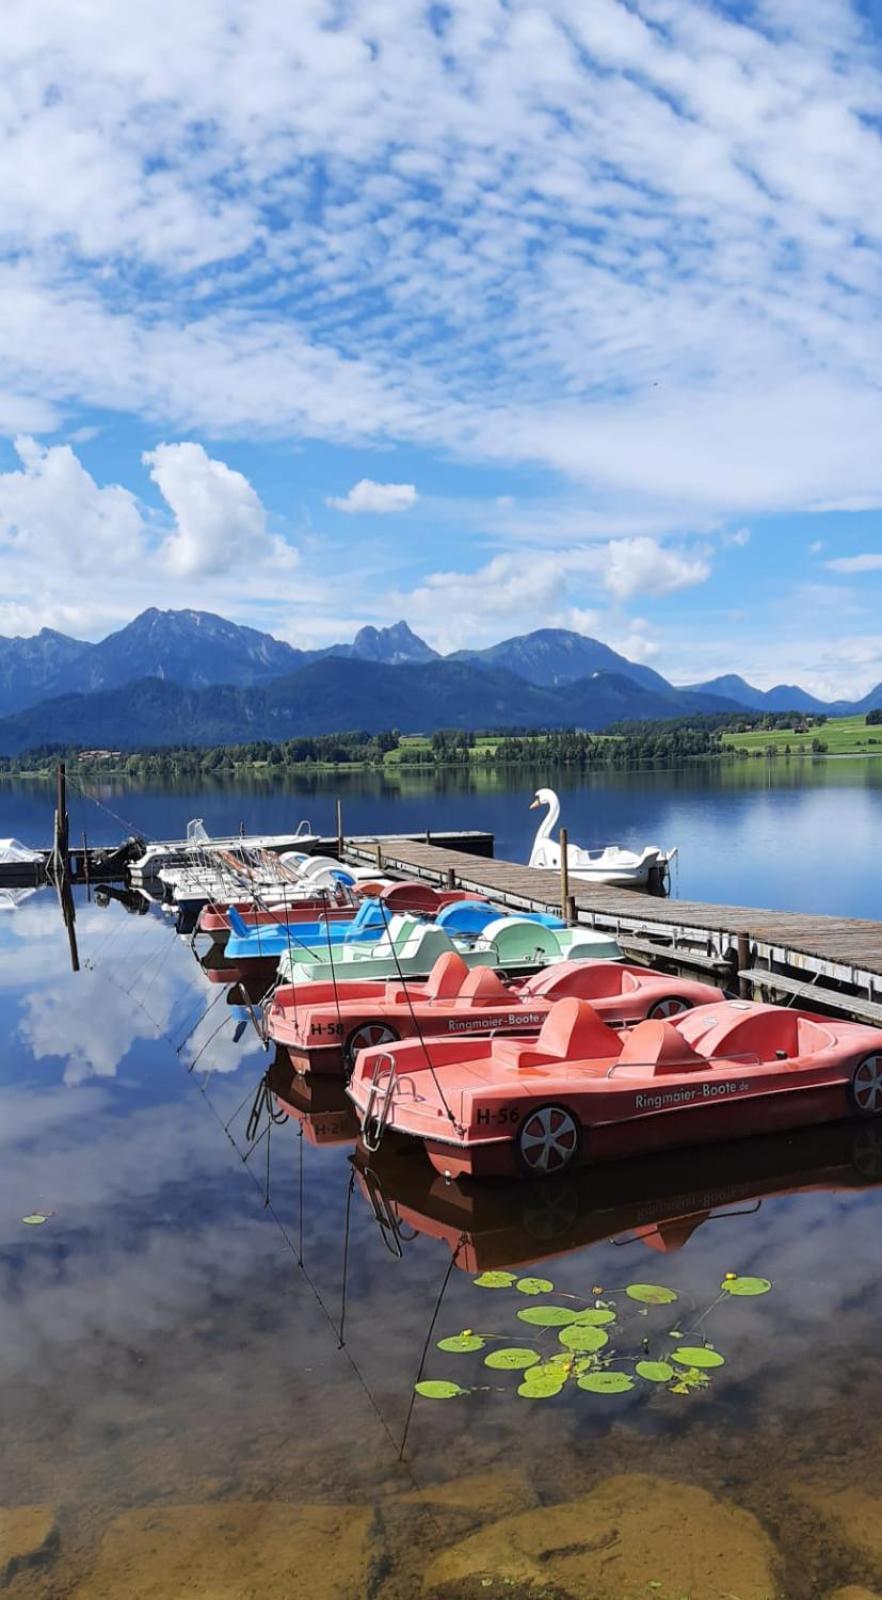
[349,998,882,1178]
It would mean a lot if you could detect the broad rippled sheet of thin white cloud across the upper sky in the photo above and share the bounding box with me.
[0,0,882,524]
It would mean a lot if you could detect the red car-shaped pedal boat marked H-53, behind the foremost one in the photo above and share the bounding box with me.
[267,950,724,1074]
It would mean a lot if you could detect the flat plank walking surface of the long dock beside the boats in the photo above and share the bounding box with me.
[347,840,882,981]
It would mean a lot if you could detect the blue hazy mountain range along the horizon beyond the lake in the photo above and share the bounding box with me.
[0,608,882,754]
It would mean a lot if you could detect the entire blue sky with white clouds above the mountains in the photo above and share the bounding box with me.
[0,0,882,694]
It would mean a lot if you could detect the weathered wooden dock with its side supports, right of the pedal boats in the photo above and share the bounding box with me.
[346,840,882,1024]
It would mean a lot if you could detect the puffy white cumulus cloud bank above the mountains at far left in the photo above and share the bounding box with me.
[0,437,307,635]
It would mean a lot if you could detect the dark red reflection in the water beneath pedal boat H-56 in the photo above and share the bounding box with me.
[354,1123,882,1272]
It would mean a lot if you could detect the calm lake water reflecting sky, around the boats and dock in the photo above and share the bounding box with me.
[0,763,882,1600]
